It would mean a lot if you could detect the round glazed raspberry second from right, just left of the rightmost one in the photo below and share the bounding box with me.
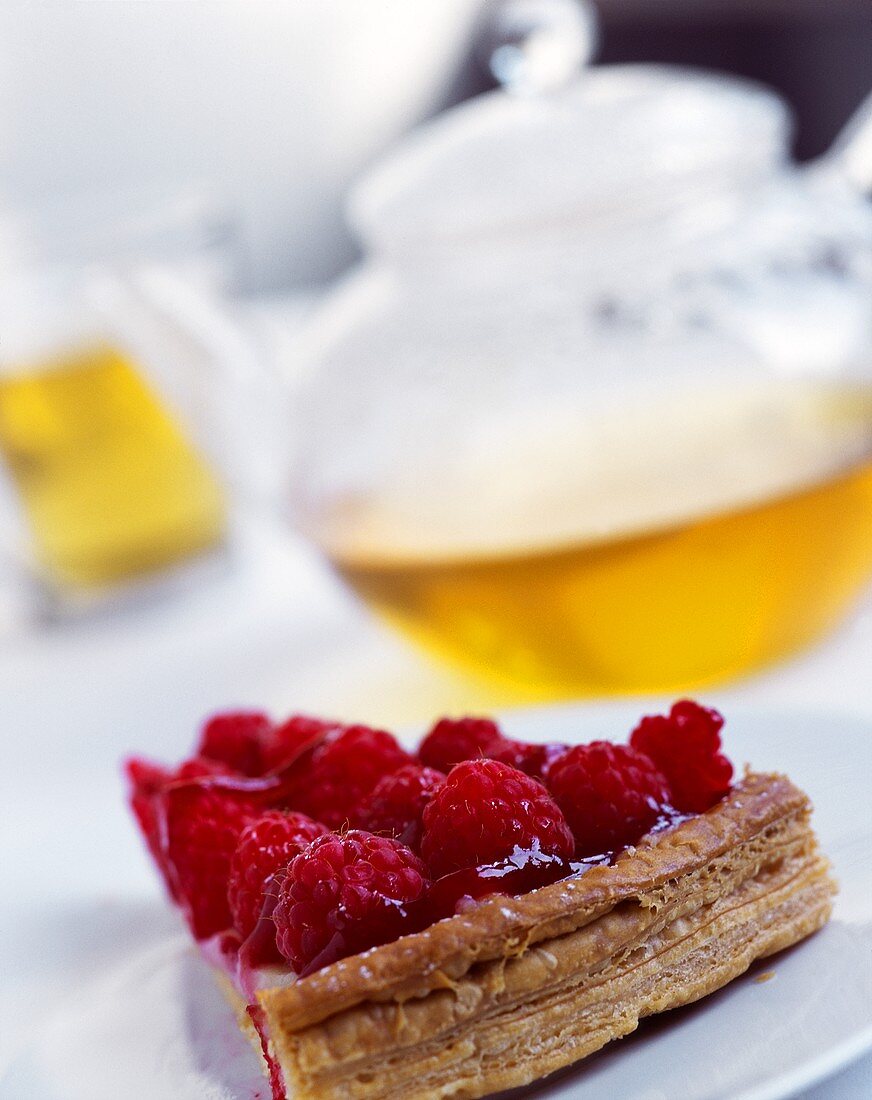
[548,741,669,856]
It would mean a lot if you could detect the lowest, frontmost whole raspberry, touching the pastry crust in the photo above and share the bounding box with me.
[273,829,427,974]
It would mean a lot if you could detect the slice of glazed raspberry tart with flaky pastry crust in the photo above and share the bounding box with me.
[126,700,835,1100]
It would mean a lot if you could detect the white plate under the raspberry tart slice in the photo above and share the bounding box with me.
[0,704,872,1100]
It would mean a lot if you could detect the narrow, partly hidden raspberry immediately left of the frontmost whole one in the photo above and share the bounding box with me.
[228,810,327,939]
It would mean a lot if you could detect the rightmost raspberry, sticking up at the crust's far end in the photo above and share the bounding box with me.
[630,699,732,814]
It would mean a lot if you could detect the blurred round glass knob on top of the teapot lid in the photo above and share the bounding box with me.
[478,0,598,96]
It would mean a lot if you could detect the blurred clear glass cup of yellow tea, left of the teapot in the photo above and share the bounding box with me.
[0,194,229,611]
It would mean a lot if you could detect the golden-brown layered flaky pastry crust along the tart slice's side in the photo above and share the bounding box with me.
[215,773,836,1100]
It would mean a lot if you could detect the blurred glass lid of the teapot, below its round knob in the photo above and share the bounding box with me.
[349,64,791,252]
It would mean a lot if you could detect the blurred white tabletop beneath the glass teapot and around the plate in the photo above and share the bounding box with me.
[0,517,872,1100]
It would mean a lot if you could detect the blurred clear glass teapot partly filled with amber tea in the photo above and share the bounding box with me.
[294,17,872,695]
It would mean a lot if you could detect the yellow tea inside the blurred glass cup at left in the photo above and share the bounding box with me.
[0,343,225,590]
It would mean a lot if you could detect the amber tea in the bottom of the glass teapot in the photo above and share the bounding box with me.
[318,382,872,695]
